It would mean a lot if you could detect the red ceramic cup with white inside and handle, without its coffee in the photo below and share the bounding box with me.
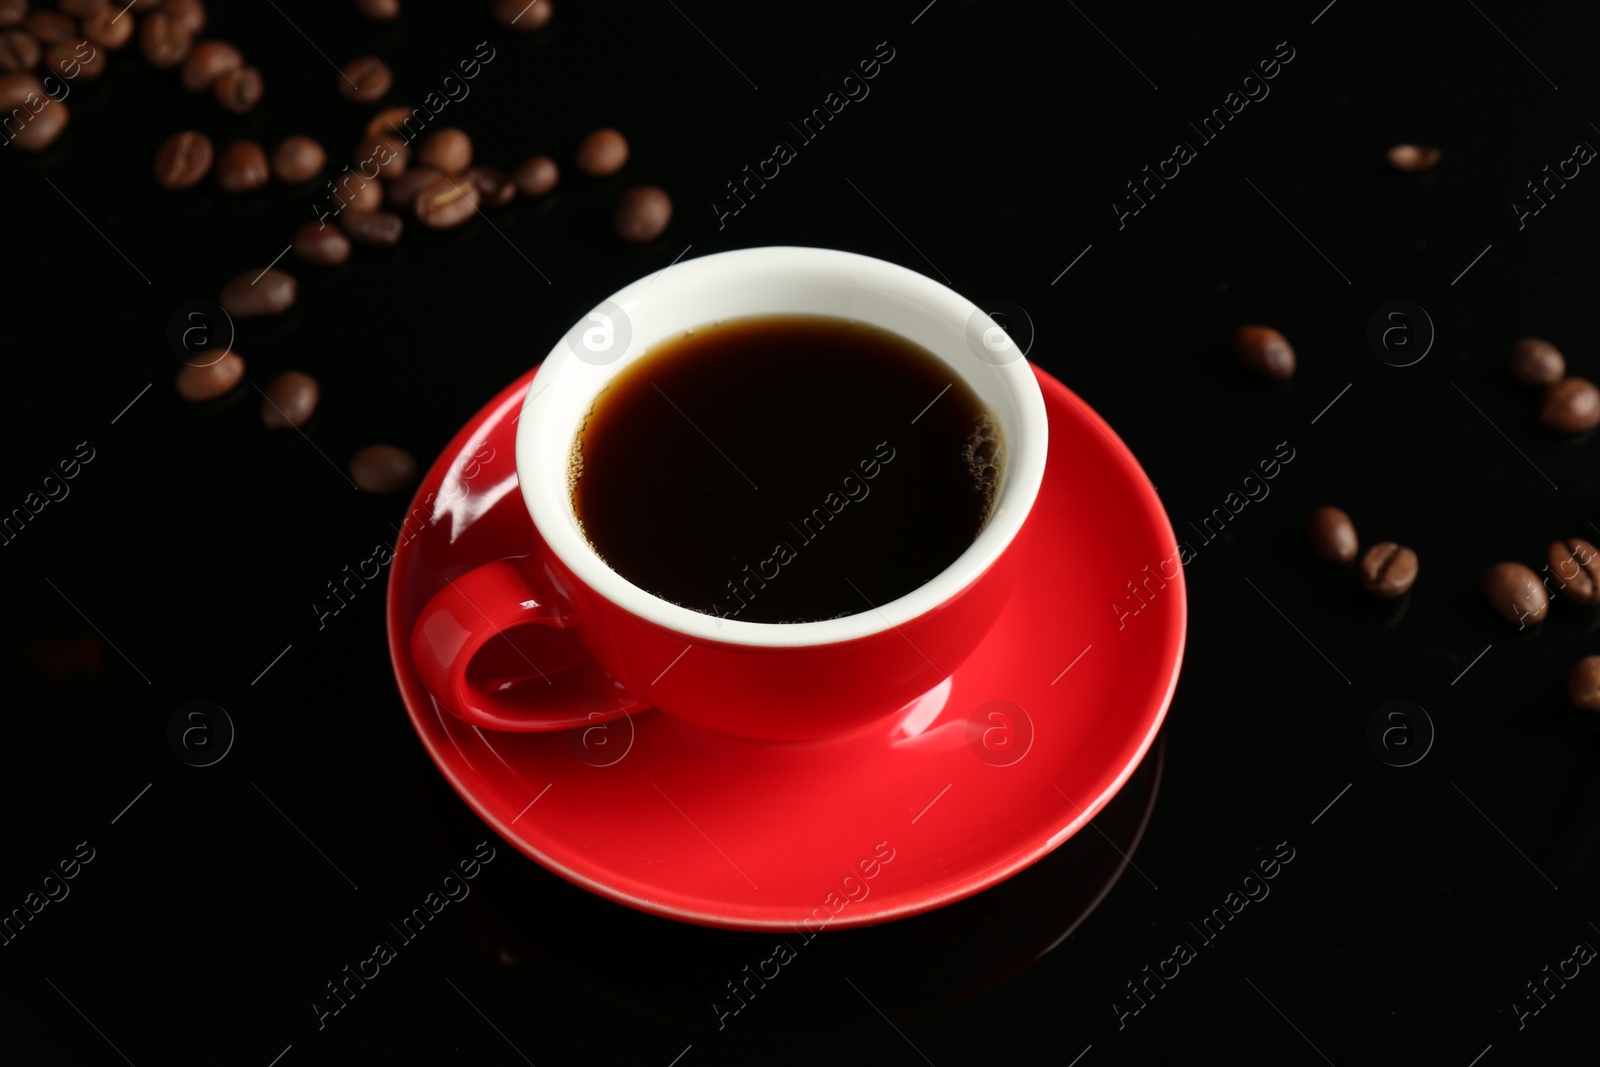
[411,248,1048,741]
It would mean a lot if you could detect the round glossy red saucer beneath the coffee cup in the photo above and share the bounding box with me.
[389,368,1187,931]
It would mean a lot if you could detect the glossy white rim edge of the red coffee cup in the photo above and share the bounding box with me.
[517,245,1048,648]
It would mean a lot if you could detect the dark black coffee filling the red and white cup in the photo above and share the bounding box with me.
[571,315,1003,622]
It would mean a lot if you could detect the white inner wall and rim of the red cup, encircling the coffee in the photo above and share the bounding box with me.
[517,248,1048,648]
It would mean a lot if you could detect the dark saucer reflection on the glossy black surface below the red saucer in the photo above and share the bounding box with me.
[419,736,1165,1033]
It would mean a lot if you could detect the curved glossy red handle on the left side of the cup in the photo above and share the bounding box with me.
[411,560,650,733]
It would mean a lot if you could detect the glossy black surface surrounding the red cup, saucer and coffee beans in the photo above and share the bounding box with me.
[0,0,1600,1067]
